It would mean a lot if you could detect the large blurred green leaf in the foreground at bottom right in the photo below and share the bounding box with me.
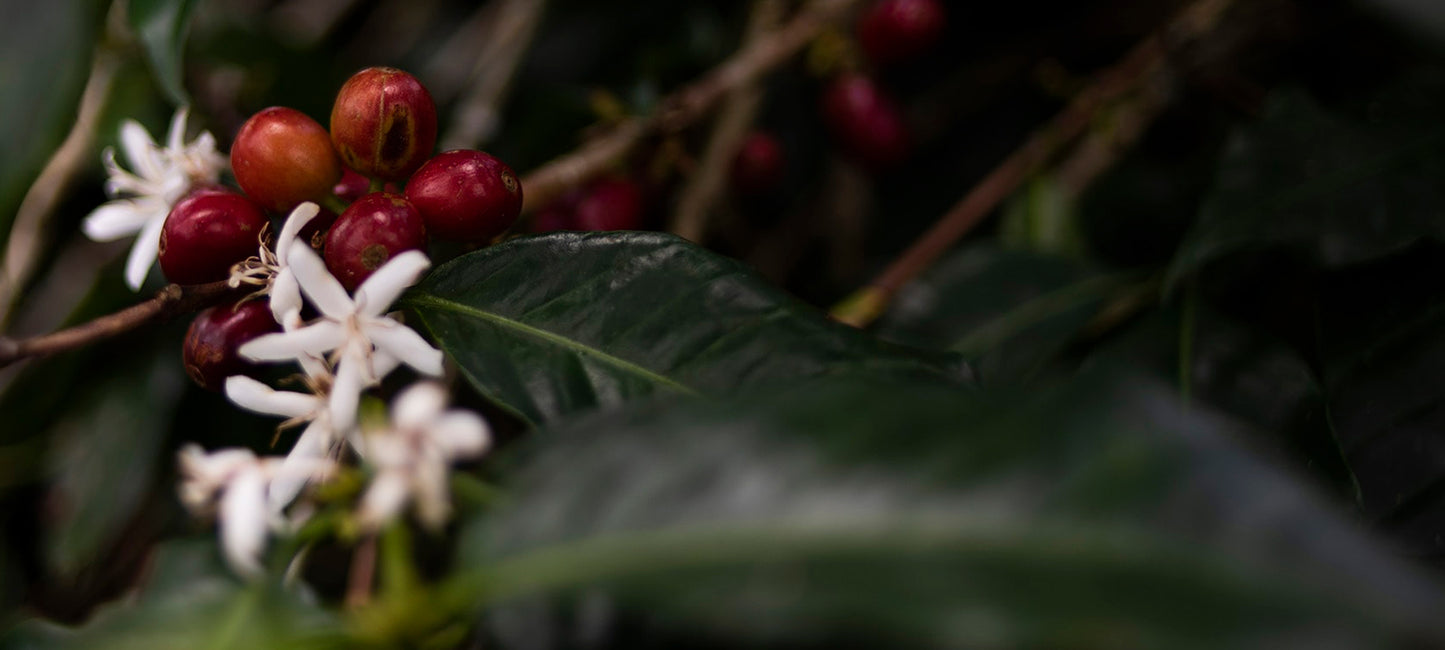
[462,373,1441,649]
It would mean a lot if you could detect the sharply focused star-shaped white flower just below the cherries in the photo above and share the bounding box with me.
[240,246,442,430]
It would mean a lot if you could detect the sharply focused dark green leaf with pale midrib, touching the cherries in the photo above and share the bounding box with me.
[402,233,961,422]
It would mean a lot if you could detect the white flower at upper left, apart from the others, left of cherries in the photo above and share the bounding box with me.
[82,108,225,290]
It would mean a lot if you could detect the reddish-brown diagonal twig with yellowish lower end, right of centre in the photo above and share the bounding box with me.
[832,0,1234,326]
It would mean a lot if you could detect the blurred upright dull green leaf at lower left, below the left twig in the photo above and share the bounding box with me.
[45,341,186,575]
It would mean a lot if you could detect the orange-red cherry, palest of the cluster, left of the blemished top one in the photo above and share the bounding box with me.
[231,107,341,212]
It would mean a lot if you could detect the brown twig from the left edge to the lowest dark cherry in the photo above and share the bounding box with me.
[0,280,246,368]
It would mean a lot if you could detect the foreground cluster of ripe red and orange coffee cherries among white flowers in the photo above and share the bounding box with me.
[177,68,522,390]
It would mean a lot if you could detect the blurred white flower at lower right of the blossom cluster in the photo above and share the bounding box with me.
[357,381,491,530]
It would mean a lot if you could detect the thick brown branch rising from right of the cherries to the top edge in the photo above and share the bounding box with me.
[522,0,858,212]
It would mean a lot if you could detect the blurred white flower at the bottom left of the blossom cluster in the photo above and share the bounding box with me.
[179,443,329,578]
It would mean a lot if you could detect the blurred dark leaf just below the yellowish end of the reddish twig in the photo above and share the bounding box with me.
[879,246,1137,383]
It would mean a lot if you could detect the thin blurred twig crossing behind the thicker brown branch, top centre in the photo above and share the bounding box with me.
[668,0,785,243]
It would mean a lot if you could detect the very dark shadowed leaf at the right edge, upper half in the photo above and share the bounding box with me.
[1170,87,1445,285]
